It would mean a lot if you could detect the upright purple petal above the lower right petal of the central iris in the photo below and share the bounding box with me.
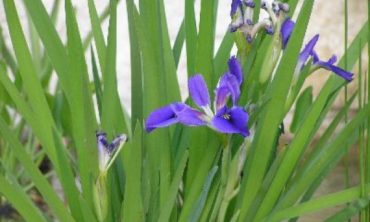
[215,73,240,111]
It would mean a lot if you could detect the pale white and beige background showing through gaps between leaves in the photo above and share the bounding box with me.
[0,0,367,221]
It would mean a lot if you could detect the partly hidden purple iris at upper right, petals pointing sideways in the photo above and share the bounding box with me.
[281,18,353,82]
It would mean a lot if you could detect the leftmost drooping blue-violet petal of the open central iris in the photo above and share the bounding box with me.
[145,104,180,133]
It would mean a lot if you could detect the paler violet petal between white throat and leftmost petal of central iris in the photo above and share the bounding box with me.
[171,103,206,126]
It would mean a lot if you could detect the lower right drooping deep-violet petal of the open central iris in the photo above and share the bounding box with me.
[212,106,249,137]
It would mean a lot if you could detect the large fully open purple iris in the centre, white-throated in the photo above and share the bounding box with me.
[145,56,249,137]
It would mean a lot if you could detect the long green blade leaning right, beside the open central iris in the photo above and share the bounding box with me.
[240,0,314,221]
